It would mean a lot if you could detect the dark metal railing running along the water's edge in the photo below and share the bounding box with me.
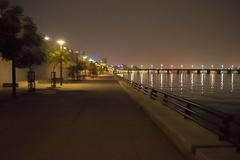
[117,76,240,151]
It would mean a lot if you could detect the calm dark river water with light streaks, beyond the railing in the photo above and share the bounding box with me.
[122,72,240,119]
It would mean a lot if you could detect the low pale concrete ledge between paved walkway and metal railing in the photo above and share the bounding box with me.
[118,79,240,160]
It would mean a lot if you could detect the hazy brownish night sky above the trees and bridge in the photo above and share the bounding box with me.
[10,0,240,67]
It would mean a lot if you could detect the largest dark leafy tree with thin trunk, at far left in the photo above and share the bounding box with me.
[0,1,42,97]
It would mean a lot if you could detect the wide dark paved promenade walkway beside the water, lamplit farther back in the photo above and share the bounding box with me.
[0,77,184,160]
